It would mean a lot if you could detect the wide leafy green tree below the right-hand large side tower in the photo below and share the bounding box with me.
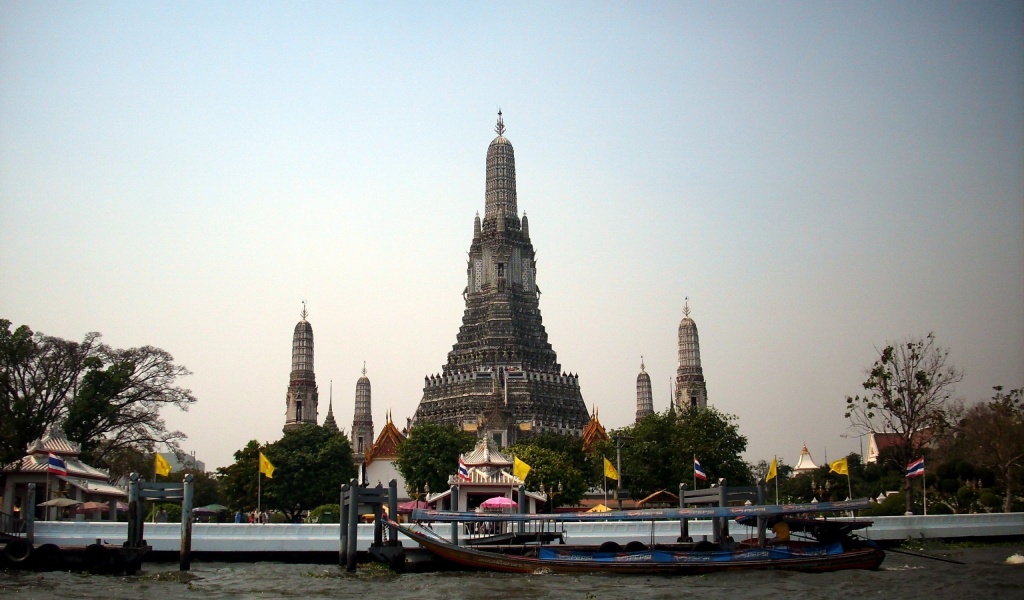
[598,406,753,499]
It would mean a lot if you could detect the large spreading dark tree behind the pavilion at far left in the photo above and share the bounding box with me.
[0,319,196,466]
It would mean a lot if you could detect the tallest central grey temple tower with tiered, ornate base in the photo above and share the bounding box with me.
[415,111,589,445]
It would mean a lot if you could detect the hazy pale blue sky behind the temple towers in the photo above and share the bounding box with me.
[0,1,1024,469]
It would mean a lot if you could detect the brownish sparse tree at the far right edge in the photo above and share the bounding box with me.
[957,386,1024,512]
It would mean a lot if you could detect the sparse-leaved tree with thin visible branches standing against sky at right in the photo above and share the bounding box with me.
[846,333,964,512]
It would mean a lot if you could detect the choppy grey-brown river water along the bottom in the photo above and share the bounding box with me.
[0,544,1024,600]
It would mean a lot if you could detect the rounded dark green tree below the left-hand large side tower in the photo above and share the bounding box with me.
[263,423,356,521]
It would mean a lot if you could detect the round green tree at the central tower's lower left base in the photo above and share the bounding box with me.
[395,423,476,494]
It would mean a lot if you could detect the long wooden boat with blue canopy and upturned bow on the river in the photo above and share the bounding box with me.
[388,500,885,574]
